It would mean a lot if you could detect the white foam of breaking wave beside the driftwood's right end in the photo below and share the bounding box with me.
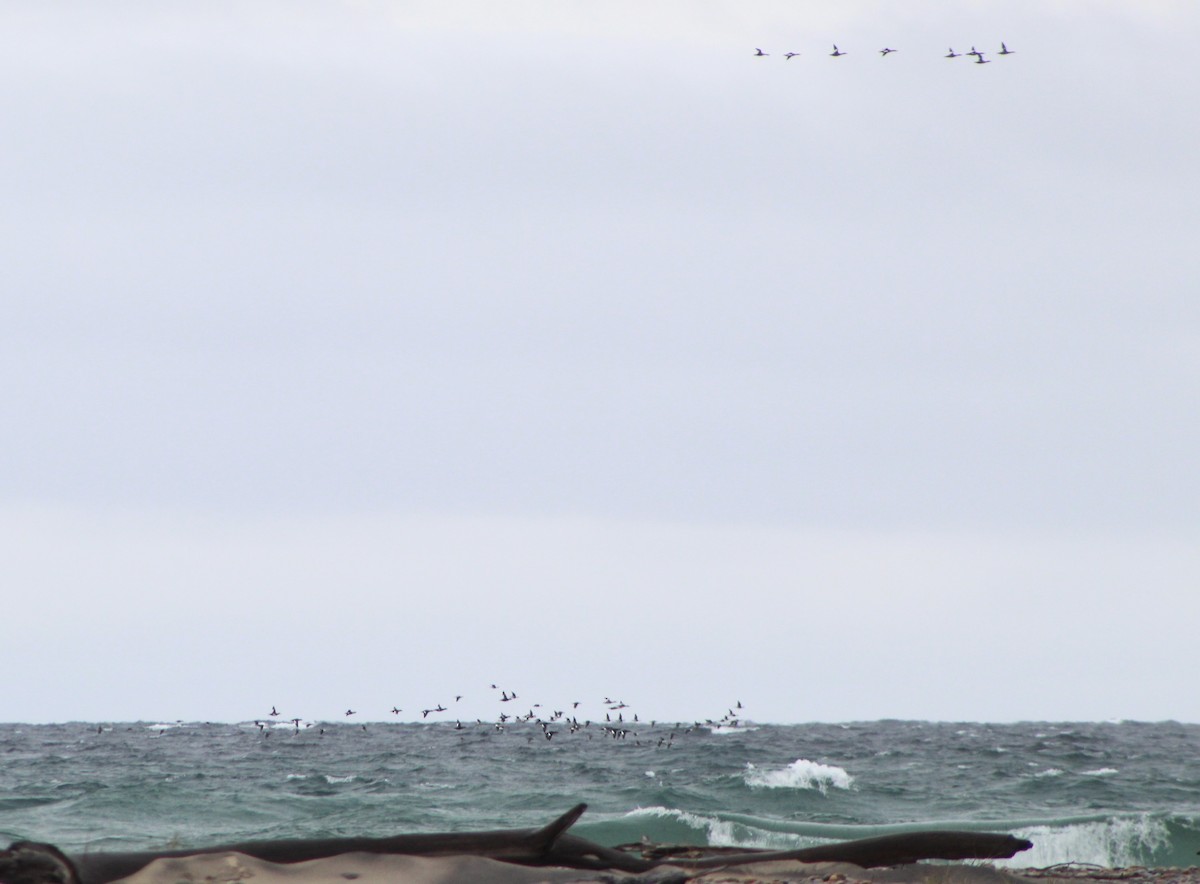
[997,814,1170,868]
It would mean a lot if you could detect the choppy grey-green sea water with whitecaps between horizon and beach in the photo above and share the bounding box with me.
[0,721,1200,866]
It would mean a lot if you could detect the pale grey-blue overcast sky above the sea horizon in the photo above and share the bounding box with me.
[0,0,1200,722]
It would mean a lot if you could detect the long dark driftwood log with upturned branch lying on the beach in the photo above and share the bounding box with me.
[0,804,1032,884]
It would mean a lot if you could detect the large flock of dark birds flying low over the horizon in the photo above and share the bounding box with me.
[246,684,744,748]
